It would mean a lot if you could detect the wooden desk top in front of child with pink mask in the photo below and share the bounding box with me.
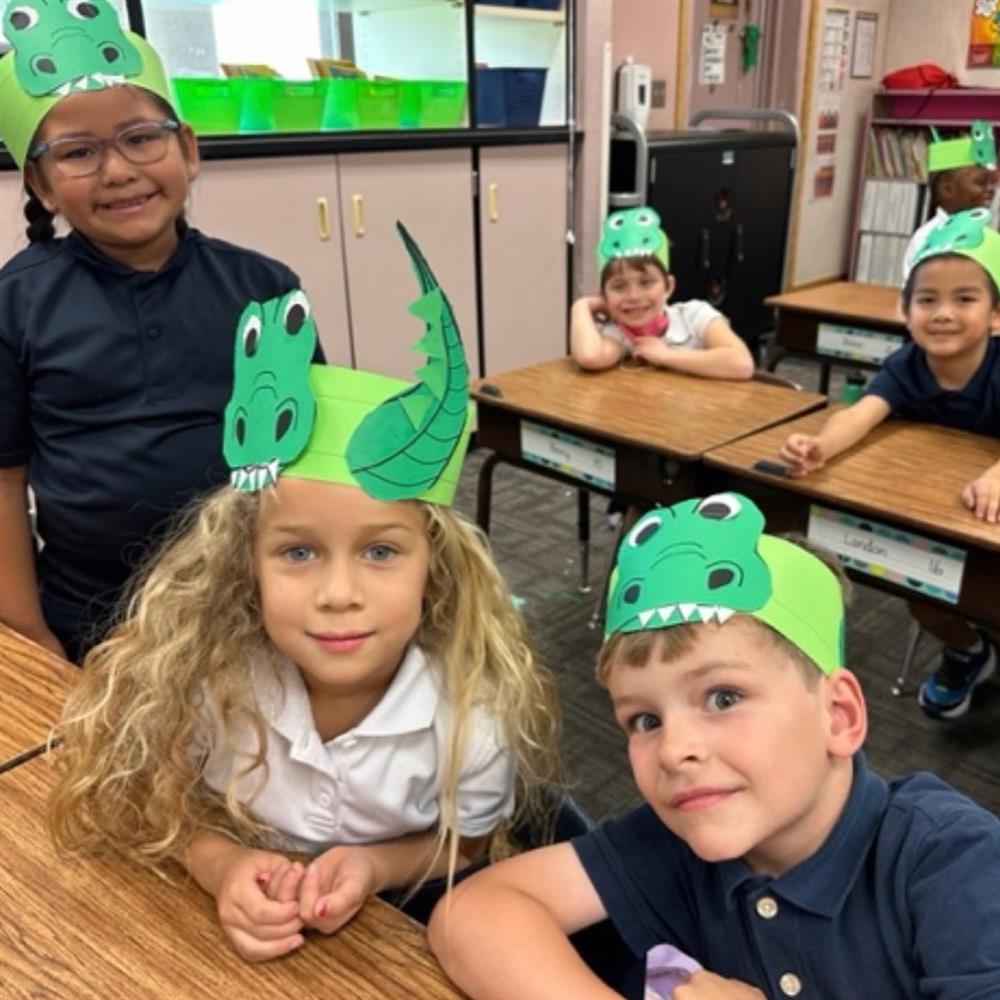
[472,358,826,460]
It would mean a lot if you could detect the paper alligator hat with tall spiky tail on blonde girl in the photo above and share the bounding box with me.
[222,223,471,505]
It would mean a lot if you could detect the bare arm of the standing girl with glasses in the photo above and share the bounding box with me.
[0,465,66,657]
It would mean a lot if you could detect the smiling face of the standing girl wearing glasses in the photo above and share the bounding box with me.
[25,86,198,271]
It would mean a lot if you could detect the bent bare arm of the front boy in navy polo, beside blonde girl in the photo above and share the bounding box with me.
[428,843,619,1000]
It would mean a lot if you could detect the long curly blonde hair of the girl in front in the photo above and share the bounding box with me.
[48,487,560,877]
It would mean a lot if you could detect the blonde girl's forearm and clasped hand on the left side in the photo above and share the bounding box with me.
[182,830,304,962]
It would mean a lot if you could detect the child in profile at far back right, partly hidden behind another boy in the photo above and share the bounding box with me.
[903,120,997,282]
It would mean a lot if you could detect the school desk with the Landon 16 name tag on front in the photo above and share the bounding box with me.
[705,412,1000,640]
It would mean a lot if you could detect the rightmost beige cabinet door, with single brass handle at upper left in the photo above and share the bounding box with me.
[479,145,569,375]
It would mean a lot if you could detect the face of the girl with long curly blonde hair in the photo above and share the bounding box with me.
[254,476,430,732]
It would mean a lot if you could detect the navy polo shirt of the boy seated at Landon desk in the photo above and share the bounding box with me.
[865,337,1000,436]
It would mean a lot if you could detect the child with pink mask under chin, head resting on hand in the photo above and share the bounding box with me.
[570,208,754,379]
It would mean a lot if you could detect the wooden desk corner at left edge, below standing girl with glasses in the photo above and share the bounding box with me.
[0,625,78,771]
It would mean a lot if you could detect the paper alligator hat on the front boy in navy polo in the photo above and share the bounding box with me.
[604,493,844,673]
